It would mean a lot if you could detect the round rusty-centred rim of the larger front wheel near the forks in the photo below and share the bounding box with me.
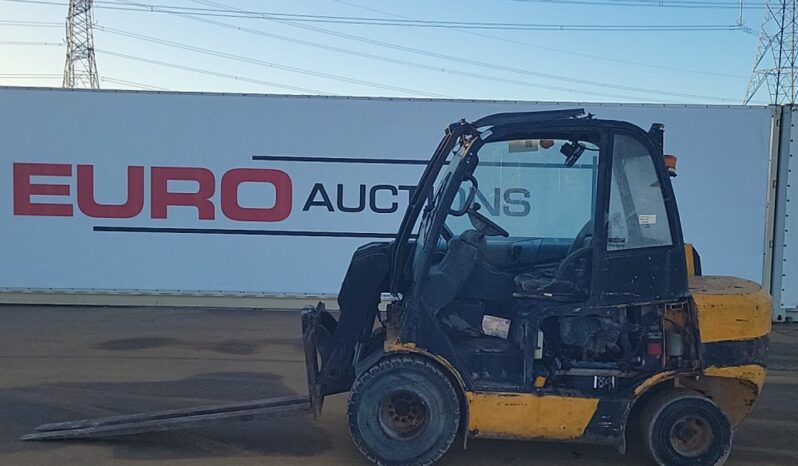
[379,391,427,440]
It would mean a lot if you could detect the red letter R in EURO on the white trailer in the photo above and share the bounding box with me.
[150,167,216,220]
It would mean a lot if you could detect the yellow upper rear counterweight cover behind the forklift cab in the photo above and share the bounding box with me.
[689,276,771,343]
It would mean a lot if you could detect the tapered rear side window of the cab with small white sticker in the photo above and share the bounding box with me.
[607,135,673,251]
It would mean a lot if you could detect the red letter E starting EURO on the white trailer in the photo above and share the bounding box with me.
[14,163,72,217]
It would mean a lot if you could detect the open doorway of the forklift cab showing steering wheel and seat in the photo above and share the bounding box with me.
[443,134,599,302]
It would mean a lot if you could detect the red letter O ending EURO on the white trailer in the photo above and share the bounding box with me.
[222,168,292,222]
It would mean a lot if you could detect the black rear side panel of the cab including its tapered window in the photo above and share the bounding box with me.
[593,130,689,306]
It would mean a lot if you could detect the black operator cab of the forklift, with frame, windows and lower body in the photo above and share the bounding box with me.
[394,112,689,390]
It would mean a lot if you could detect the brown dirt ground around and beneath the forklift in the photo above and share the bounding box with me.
[0,306,798,466]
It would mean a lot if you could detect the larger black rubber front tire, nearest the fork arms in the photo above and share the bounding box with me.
[347,355,461,466]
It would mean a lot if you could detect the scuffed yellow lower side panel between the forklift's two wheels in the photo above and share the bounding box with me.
[466,392,599,440]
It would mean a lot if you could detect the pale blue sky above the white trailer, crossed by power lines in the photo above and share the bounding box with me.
[0,0,768,104]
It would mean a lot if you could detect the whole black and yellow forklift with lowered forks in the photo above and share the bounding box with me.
[23,109,771,465]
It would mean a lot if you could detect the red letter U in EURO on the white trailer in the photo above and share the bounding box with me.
[78,165,144,218]
